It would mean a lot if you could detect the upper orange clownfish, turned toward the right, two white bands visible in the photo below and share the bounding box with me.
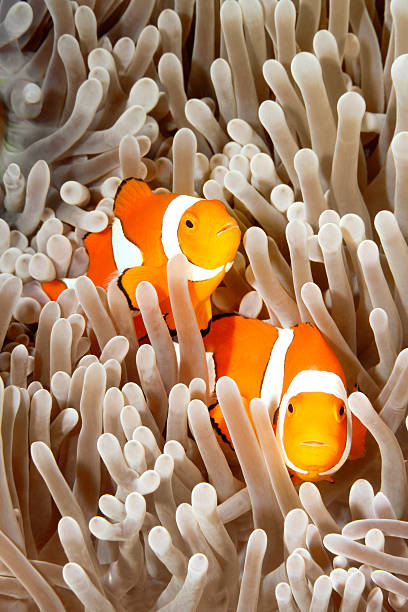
[42,178,241,339]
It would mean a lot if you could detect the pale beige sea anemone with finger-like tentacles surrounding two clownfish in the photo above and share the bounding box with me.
[0,0,408,612]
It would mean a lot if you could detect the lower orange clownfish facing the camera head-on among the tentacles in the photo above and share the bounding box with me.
[204,315,366,484]
